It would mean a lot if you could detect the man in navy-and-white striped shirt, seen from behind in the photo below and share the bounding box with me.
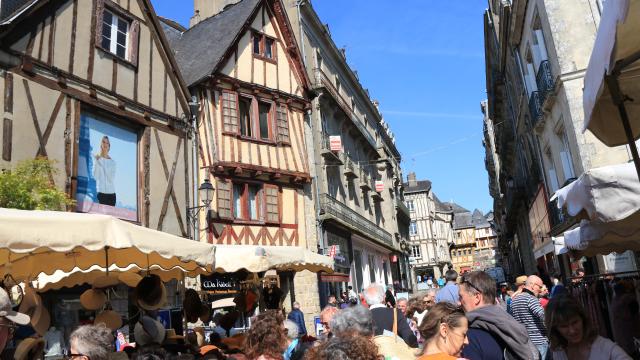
[511,275,549,359]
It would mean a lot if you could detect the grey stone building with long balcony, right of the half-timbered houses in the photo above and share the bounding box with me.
[284,0,409,301]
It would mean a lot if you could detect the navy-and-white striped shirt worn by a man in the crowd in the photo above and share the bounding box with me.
[511,289,548,346]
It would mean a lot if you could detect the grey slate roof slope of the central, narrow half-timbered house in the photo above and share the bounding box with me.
[162,0,261,86]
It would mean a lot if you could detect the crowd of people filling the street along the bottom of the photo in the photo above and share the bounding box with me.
[0,270,631,360]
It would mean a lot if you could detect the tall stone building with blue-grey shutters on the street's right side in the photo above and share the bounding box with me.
[482,0,630,274]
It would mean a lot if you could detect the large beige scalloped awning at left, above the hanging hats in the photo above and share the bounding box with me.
[0,208,215,281]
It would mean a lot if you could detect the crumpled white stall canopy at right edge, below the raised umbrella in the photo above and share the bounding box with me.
[551,163,640,256]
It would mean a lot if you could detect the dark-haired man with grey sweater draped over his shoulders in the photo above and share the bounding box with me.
[459,271,537,360]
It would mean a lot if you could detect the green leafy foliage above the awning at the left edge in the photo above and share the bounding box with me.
[0,157,74,210]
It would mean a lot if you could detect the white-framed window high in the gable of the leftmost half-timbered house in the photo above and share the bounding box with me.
[96,0,140,64]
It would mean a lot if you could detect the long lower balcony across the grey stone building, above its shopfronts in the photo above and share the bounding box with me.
[320,194,393,247]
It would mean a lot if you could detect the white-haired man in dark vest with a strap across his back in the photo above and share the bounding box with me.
[364,284,418,348]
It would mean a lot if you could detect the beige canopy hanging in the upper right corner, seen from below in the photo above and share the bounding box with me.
[583,0,640,174]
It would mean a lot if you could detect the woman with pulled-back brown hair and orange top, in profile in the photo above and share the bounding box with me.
[418,301,469,360]
